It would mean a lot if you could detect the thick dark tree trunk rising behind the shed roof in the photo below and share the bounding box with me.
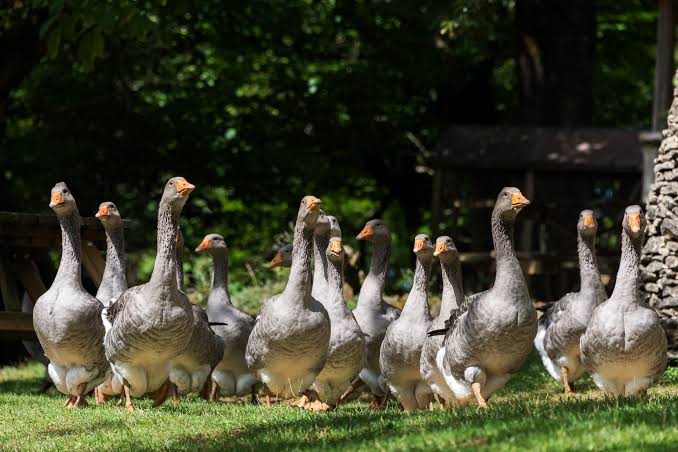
[515,0,596,126]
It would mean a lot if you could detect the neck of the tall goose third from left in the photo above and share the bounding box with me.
[150,201,179,289]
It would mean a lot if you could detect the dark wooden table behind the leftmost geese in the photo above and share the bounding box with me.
[0,211,130,339]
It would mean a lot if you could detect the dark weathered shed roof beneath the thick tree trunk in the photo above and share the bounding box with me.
[430,125,643,173]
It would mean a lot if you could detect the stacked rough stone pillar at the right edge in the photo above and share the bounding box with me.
[641,69,678,357]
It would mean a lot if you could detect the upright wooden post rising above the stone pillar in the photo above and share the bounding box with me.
[652,0,676,131]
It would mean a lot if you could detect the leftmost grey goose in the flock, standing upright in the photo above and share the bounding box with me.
[33,182,110,408]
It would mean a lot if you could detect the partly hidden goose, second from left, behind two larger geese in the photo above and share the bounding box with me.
[94,201,127,404]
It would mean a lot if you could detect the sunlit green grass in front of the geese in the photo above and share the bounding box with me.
[0,355,678,451]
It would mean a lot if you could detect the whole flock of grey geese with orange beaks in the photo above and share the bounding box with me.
[33,177,667,411]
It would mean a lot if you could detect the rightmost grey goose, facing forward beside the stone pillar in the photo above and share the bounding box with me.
[580,205,667,397]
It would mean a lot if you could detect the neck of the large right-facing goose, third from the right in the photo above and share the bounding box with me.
[492,212,526,290]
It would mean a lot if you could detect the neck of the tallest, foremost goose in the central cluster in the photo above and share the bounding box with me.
[283,220,313,304]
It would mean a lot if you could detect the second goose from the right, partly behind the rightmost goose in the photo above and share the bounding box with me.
[534,209,607,394]
